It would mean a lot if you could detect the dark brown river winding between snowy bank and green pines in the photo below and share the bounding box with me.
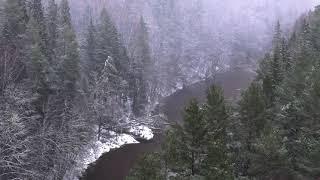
[80,70,255,180]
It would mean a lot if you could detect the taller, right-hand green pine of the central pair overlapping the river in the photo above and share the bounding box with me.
[203,85,233,179]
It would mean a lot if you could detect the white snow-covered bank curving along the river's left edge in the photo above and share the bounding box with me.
[64,125,154,180]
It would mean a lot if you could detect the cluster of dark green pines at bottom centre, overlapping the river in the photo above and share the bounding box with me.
[129,86,233,180]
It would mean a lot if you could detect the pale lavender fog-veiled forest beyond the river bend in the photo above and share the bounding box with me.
[65,0,317,92]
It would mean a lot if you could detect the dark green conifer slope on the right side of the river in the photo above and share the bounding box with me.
[127,6,320,180]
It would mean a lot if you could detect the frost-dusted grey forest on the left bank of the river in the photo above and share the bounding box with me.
[0,0,154,179]
